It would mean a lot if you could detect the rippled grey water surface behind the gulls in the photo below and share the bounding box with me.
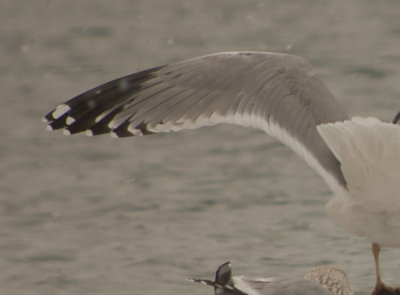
[0,0,400,295]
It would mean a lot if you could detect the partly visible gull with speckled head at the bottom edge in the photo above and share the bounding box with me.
[188,262,353,295]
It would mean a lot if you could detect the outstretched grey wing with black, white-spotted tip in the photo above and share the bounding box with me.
[45,52,348,191]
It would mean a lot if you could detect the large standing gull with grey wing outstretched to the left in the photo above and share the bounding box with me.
[43,51,400,294]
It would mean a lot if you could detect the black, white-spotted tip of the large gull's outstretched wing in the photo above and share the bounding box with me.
[42,66,163,137]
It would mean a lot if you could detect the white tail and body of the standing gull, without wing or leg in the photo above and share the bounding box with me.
[317,117,400,247]
